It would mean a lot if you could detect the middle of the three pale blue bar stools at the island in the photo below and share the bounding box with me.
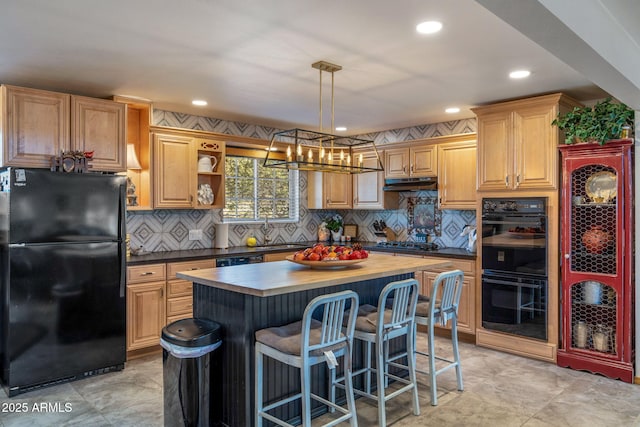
[337,279,420,426]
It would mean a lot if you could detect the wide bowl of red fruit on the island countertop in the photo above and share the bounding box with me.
[286,243,369,269]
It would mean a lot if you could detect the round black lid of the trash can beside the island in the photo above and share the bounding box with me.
[162,319,222,347]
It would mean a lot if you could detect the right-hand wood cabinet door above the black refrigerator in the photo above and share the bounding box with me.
[71,96,127,172]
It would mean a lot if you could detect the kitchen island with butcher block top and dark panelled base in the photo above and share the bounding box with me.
[177,254,450,426]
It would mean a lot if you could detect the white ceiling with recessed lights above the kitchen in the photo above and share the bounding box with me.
[0,0,640,135]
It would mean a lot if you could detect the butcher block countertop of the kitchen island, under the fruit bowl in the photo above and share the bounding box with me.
[177,253,451,297]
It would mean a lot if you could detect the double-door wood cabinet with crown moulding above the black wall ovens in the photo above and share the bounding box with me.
[473,93,580,191]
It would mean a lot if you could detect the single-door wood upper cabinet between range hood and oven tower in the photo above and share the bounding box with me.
[438,134,477,210]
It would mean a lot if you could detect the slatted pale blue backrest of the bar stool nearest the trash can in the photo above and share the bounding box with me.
[301,291,359,356]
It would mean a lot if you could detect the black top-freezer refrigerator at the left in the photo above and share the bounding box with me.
[0,168,126,396]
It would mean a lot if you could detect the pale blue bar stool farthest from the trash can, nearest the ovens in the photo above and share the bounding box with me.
[416,270,464,406]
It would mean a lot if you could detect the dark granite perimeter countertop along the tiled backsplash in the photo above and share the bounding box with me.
[127,242,476,265]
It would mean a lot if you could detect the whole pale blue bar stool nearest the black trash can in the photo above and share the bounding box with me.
[255,291,359,427]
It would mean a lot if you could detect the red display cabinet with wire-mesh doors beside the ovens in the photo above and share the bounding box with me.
[558,140,634,382]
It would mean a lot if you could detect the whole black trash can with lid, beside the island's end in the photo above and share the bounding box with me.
[160,319,222,427]
